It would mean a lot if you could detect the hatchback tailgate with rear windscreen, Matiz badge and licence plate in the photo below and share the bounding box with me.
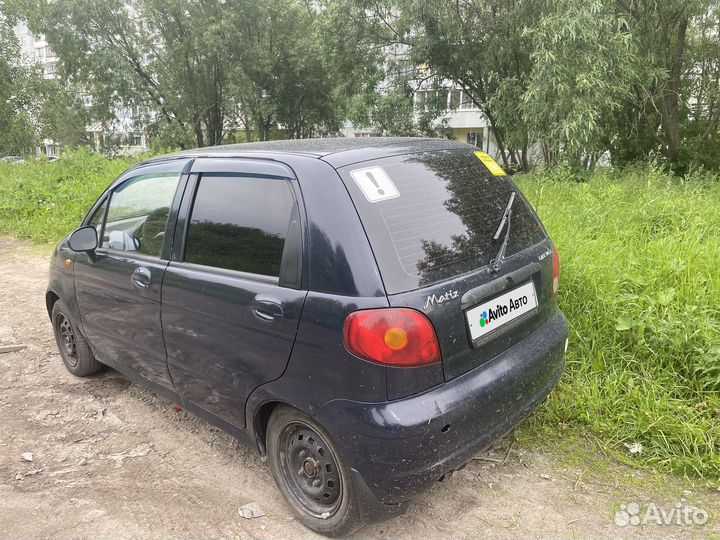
[340,148,554,379]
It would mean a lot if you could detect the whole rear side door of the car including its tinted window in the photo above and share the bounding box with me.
[162,159,306,427]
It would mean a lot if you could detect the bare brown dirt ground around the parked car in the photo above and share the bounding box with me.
[0,238,720,539]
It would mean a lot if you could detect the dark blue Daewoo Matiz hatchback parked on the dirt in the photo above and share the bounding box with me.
[47,138,567,535]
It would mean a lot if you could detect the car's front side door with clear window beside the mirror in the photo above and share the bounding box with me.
[74,160,187,389]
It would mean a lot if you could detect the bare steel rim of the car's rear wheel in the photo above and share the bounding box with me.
[279,422,343,519]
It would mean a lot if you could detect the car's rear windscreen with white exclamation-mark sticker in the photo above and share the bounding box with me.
[339,149,545,294]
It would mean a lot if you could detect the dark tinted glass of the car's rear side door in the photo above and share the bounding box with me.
[185,174,296,277]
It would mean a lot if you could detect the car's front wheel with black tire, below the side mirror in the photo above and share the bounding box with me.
[51,300,103,377]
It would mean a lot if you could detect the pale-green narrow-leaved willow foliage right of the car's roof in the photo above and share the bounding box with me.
[521,0,637,163]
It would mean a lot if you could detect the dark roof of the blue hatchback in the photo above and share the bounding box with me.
[145,137,474,167]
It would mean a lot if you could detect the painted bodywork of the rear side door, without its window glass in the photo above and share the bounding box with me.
[162,158,307,427]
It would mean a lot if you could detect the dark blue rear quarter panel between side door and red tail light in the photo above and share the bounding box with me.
[242,156,388,435]
